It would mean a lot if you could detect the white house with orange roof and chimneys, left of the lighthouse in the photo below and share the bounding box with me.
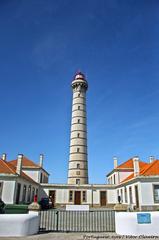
[0,154,49,204]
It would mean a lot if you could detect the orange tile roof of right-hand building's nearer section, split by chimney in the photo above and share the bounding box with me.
[122,160,159,183]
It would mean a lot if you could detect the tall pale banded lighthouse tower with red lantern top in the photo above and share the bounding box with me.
[67,72,88,185]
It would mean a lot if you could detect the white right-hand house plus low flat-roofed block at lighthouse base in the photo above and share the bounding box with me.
[42,157,159,210]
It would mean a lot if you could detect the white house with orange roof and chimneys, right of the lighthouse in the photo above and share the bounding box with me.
[107,157,159,210]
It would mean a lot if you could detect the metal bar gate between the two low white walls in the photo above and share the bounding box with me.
[40,210,115,232]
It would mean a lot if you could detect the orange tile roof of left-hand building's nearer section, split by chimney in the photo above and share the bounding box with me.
[0,159,38,184]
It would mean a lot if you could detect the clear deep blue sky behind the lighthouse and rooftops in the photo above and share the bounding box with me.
[0,0,159,183]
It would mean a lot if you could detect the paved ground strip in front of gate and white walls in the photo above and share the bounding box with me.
[0,233,159,240]
